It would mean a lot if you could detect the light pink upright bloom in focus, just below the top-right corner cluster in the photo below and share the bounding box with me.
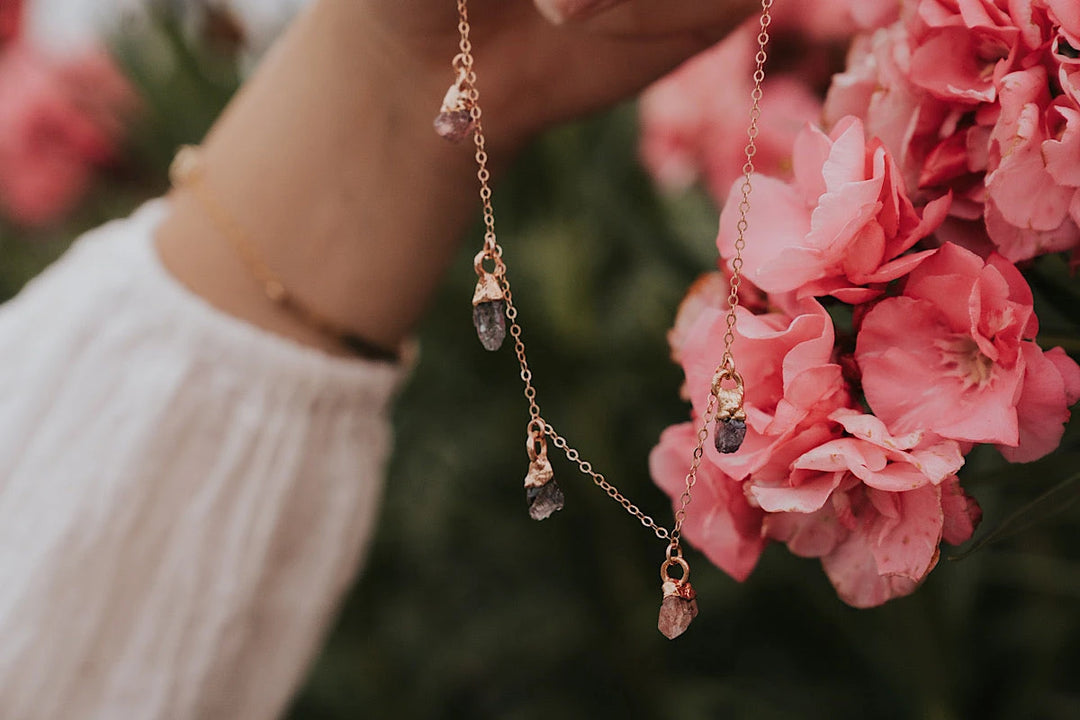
[717,118,949,302]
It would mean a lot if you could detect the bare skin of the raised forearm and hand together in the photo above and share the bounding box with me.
[157,0,758,354]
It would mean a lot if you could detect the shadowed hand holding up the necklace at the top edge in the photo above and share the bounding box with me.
[349,0,758,147]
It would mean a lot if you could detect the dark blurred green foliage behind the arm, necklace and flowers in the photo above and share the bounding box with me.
[0,7,1080,720]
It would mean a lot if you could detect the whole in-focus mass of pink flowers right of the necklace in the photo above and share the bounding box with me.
[651,0,1080,607]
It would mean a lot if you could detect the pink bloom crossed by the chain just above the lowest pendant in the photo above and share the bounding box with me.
[649,423,765,581]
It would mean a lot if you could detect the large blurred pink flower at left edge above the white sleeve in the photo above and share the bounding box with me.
[0,42,135,226]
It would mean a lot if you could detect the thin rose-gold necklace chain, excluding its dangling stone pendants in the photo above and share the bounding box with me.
[454,0,773,548]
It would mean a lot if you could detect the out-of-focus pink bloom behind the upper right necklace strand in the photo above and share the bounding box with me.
[640,23,821,200]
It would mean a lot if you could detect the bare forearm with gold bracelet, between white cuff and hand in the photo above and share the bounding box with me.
[159,0,476,351]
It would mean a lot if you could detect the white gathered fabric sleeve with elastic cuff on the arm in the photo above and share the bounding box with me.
[0,201,402,720]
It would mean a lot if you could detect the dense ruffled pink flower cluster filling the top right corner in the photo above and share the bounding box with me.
[825,0,1080,262]
